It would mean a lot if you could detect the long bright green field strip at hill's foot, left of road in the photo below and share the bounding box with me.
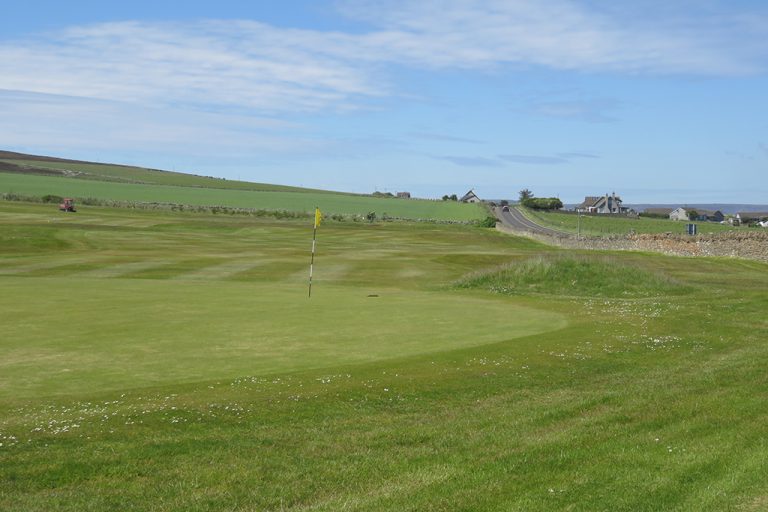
[0,173,487,221]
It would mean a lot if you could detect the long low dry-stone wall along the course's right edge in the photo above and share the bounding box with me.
[500,228,768,262]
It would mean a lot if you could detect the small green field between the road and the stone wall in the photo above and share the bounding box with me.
[521,208,746,236]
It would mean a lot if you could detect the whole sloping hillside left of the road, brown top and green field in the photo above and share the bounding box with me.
[0,151,487,222]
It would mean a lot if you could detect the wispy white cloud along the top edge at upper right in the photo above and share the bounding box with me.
[342,0,768,75]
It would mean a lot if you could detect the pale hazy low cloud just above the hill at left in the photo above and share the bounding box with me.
[0,90,334,157]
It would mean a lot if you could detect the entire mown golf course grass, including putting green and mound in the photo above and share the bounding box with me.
[0,202,768,511]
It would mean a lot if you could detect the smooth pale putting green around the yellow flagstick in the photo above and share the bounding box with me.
[0,276,566,399]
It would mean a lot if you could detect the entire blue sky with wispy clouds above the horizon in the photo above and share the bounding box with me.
[0,0,768,204]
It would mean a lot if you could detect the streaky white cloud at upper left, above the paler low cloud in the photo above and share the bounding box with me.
[0,21,384,111]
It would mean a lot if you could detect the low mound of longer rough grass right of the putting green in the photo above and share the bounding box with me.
[457,256,691,298]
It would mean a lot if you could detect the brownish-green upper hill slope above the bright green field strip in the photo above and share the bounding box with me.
[0,151,344,195]
